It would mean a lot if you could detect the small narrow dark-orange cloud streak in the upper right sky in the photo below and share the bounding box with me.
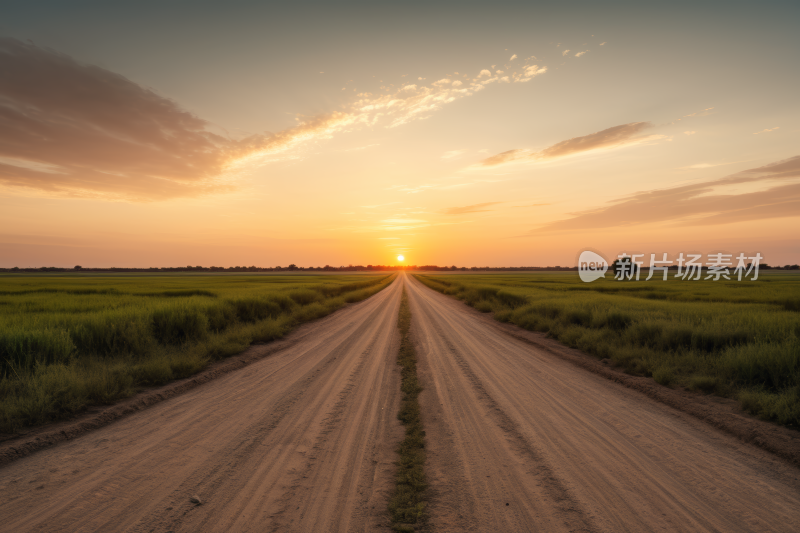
[478,122,666,167]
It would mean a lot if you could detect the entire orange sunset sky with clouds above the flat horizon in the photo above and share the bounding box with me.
[0,1,800,267]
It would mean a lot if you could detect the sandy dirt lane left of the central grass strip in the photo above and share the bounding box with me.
[0,276,402,533]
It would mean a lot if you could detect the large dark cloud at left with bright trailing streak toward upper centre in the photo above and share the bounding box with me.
[0,38,546,201]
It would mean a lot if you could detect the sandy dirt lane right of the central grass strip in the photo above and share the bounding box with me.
[407,278,800,532]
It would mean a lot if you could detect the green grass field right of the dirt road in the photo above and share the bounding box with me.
[417,271,800,427]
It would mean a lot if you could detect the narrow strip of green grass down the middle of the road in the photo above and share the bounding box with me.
[389,287,428,532]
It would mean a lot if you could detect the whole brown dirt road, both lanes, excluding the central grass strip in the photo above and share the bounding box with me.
[0,275,800,533]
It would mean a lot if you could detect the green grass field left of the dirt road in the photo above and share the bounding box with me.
[0,274,393,433]
